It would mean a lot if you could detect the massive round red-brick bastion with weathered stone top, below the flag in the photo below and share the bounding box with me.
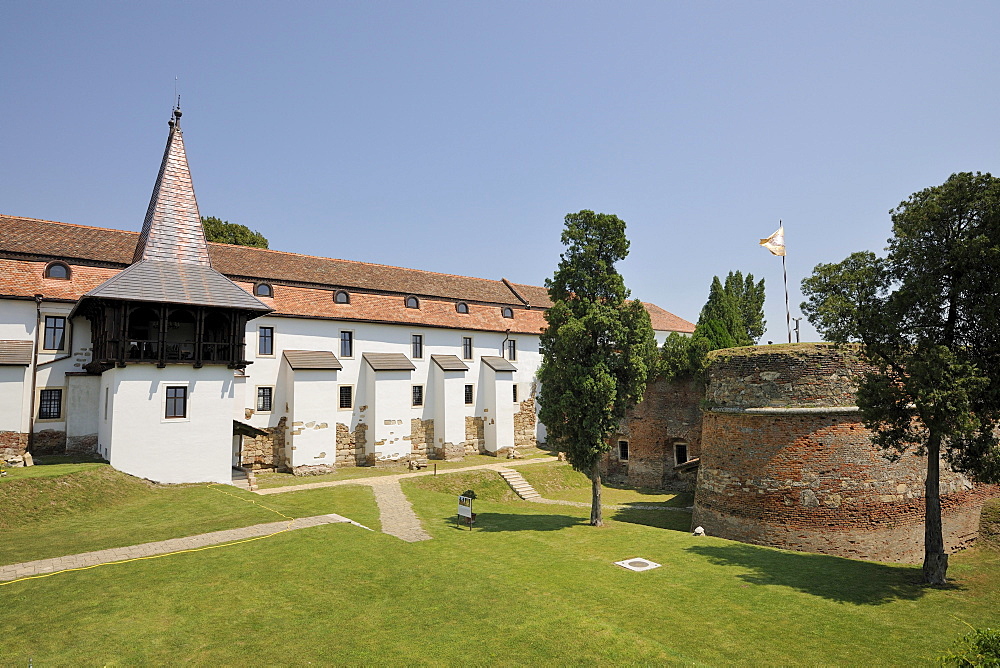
[692,344,997,563]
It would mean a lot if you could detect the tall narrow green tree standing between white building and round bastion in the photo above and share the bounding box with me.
[538,210,656,526]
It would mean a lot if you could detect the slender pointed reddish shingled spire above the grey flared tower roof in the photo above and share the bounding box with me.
[132,106,212,267]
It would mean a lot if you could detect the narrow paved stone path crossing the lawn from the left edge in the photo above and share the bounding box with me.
[0,509,368,582]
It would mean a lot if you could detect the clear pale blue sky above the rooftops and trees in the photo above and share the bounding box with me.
[0,0,1000,342]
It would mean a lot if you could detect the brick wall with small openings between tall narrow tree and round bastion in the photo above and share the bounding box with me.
[601,379,705,489]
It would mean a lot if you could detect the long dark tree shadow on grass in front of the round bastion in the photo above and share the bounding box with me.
[687,543,961,605]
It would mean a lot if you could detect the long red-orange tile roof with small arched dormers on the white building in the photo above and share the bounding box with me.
[0,215,694,334]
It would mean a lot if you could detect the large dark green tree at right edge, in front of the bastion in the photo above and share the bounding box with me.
[802,173,1000,584]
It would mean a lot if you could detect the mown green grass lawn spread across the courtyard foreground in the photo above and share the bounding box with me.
[0,462,1000,666]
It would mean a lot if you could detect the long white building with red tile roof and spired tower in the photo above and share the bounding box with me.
[0,110,694,482]
